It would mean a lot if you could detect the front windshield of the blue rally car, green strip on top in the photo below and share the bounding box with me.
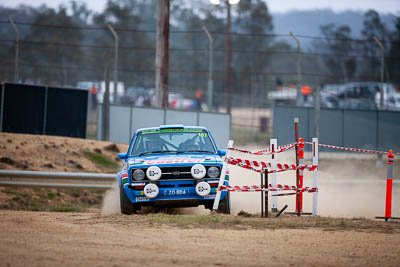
[131,128,215,156]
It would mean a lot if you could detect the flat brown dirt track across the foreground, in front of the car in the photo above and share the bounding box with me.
[0,210,400,266]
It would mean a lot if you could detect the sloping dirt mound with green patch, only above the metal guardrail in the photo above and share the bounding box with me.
[0,133,128,173]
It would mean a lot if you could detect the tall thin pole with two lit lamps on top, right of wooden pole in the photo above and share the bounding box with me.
[209,0,240,114]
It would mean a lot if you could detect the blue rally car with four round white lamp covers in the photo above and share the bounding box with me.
[118,125,229,214]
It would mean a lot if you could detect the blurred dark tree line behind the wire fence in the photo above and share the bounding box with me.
[0,0,400,97]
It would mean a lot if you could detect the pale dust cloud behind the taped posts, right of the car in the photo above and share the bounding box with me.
[230,150,400,218]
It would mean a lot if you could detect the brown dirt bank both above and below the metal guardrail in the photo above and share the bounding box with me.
[0,133,128,211]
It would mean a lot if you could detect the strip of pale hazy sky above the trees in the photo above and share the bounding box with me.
[0,0,400,15]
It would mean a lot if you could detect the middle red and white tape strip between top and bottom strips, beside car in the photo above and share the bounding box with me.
[225,157,318,173]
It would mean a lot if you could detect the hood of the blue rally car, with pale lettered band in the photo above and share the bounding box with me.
[128,154,222,166]
